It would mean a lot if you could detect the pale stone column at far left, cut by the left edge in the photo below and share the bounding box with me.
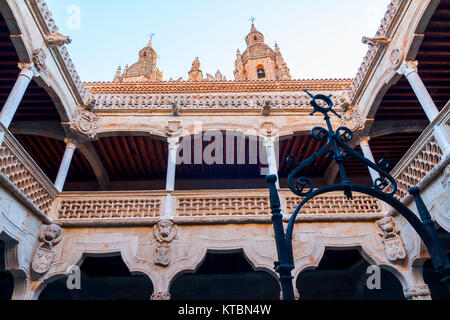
[0,63,37,128]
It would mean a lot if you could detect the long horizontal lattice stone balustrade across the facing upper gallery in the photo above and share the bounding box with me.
[52,189,381,226]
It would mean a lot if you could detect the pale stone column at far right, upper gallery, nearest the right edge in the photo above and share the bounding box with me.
[397,61,450,155]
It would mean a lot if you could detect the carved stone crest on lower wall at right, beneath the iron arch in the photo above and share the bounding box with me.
[377,217,406,262]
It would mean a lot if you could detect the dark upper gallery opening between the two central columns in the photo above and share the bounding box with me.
[175,130,268,190]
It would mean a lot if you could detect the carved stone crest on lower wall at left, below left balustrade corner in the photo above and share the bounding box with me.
[31,224,64,275]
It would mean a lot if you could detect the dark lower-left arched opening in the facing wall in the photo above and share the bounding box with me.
[39,255,153,300]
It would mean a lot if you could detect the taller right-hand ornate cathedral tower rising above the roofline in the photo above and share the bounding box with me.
[234,23,291,81]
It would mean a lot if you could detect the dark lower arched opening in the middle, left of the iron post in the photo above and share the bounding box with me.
[170,251,280,300]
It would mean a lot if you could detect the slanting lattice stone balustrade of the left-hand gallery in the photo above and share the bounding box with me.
[0,124,58,215]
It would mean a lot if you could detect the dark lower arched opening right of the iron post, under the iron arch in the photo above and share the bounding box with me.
[296,249,404,300]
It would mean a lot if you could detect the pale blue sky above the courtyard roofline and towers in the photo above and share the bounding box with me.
[47,0,390,81]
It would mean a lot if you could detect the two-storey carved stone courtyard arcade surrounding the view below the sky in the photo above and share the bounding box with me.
[0,0,450,299]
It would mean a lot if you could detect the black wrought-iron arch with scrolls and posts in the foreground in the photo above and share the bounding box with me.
[266,90,450,300]
